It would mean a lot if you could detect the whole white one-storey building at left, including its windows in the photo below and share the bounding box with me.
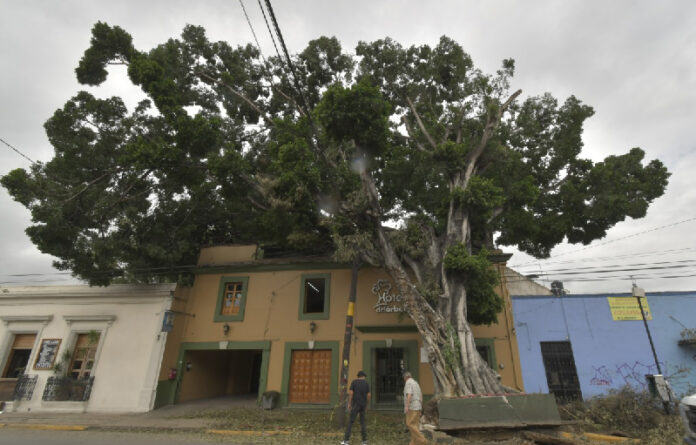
[0,284,175,412]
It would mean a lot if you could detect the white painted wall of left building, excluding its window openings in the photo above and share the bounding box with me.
[0,284,175,412]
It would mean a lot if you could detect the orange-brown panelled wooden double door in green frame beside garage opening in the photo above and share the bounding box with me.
[288,349,331,404]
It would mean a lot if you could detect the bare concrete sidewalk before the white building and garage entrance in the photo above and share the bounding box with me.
[0,397,260,432]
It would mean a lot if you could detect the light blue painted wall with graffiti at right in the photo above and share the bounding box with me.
[512,291,696,399]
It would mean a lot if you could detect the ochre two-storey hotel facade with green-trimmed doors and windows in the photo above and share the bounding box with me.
[152,246,522,409]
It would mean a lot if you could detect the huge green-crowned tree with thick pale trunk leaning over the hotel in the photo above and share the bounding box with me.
[2,23,669,396]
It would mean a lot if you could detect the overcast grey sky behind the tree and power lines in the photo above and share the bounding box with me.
[0,0,696,294]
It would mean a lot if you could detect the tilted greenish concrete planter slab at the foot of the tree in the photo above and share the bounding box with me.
[438,394,561,431]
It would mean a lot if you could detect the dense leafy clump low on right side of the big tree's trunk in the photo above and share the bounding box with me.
[444,243,504,325]
